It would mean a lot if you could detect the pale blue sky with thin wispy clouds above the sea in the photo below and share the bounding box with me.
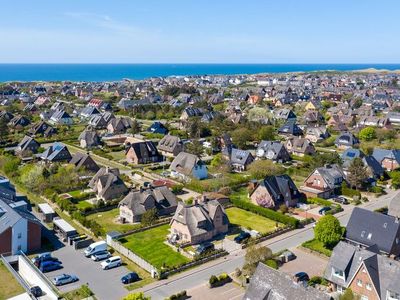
[0,0,400,63]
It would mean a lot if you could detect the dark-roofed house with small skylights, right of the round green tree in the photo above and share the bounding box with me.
[345,207,400,257]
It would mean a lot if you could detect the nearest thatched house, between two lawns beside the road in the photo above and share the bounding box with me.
[170,200,229,244]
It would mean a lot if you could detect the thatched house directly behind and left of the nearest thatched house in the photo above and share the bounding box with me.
[118,186,178,223]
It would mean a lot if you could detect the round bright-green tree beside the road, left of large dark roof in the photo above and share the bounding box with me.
[314,215,343,248]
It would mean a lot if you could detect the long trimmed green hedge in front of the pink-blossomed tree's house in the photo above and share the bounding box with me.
[231,199,300,228]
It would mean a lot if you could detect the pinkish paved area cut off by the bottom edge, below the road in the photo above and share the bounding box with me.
[187,283,245,300]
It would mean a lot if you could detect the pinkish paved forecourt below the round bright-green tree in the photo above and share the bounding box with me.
[279,248,328,278]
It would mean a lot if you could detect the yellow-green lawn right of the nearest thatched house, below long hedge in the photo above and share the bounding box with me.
[226,207,283,233]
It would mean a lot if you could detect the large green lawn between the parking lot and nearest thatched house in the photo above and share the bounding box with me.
[120,224,189,268]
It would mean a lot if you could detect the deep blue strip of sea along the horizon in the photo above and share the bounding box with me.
[0,64,400,82]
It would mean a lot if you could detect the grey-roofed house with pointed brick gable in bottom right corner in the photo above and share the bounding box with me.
[324,241,400,300]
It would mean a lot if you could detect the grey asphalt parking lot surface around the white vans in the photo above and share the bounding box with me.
[45,241,129,300]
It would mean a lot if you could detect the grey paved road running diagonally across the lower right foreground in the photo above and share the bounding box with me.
[142,191,398,299]
